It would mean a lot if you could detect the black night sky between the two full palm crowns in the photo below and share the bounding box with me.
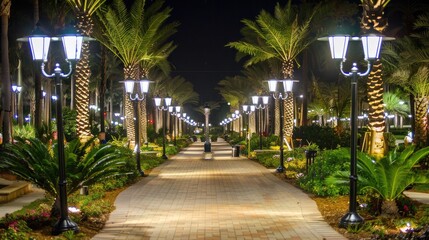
[162,0,285,104]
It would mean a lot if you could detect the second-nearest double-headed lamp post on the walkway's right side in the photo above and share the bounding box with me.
[268,79,294,173]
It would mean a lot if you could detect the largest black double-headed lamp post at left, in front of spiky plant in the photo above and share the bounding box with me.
[18,25,84,235]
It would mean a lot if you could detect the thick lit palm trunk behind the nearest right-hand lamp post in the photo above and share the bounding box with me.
[361,0,390,157]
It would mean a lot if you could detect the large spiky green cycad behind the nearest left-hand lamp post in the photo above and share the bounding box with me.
[0,137,132,200]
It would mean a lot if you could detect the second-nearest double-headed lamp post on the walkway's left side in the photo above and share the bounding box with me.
[124,79,150,176]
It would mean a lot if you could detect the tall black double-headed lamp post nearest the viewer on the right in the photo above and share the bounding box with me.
[319,30,393,228]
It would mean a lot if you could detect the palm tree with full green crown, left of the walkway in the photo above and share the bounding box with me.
[95,0,177,147]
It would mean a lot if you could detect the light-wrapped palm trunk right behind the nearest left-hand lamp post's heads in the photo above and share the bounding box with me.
[67,0,106,140]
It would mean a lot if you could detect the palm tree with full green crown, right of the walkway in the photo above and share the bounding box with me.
[227,1,320,149]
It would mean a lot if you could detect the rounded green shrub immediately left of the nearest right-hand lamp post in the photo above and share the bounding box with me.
[298,148,350,196]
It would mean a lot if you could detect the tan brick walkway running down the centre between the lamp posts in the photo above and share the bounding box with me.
[93,142,345,240]
